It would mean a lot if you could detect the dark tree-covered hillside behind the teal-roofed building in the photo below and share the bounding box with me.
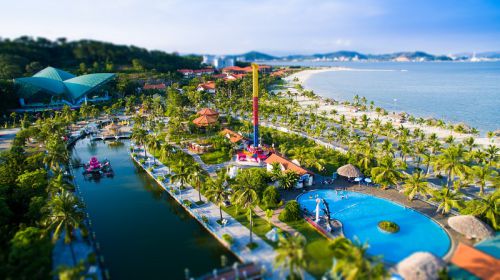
[0,36,201,79]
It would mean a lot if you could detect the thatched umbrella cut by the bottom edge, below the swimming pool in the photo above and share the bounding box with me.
[397,252,445,280]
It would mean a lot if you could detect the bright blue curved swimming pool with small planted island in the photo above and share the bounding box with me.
[297,190,451,263]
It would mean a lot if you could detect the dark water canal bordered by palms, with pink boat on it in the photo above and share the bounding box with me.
[72,139,236,279]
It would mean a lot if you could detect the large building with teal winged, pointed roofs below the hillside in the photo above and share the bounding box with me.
[14,67,115,108]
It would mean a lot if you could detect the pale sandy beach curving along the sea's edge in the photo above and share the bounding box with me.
[285,67,500,146]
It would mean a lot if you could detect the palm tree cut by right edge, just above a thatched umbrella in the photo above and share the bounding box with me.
[461,190,500,230]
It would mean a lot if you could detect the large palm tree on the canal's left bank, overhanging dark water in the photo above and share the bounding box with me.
[43,190,85,264]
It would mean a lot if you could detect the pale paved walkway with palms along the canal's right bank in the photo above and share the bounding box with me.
[132,149,313,279]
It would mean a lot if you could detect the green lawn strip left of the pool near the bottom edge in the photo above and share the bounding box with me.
[288,220,333,278]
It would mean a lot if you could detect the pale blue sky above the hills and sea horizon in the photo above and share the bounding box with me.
[0,0,500,55]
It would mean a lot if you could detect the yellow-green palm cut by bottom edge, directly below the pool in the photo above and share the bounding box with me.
[330,237,388,280]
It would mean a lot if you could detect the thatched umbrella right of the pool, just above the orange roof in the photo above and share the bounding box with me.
[448,215,495,239]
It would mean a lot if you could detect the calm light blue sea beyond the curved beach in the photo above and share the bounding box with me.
[273,62,500,134]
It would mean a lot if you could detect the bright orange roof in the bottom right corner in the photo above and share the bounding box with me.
[451,243,500,280]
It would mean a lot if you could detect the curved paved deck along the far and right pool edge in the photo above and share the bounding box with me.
[280,179,475,261]
